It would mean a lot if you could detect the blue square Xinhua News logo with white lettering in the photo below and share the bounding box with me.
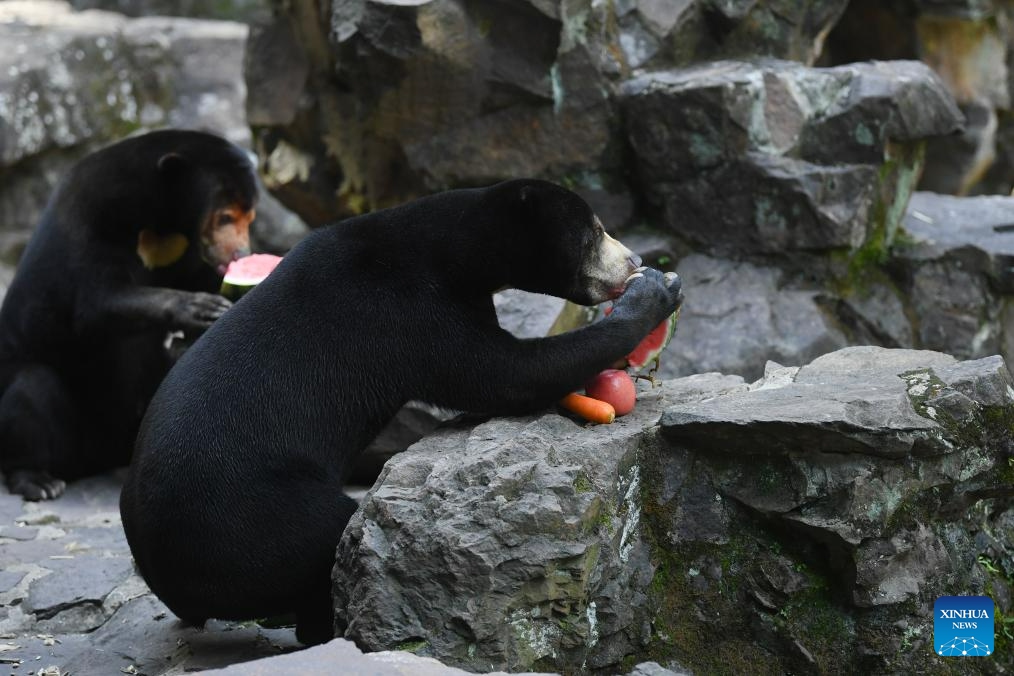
[933,596,994,657]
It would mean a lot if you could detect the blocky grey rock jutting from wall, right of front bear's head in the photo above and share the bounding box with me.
[621,62,961,255]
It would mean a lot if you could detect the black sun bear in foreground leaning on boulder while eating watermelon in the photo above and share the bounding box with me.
[120,180,681,643]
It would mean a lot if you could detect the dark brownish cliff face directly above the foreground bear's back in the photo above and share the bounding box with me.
[247,0,846,223]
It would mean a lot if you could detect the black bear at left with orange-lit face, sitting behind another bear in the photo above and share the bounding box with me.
[0,130,258,500]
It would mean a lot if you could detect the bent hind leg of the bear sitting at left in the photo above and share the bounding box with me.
[0,364,78,501]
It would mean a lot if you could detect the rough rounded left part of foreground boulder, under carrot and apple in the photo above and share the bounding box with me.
[335,374,741,671]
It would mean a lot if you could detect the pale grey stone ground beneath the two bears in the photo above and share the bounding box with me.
[0,472,685,676]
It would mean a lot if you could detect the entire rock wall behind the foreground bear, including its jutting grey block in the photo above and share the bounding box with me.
[246,0,1014,379]
